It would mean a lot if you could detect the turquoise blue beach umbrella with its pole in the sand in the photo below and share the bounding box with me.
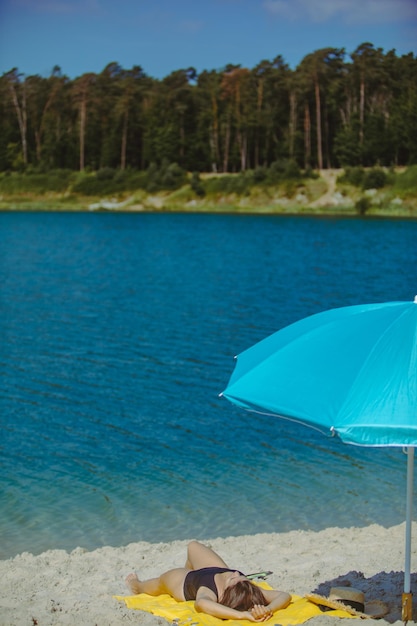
[220,296,417,621]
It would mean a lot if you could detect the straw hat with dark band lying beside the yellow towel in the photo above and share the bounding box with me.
[305,587,388,619]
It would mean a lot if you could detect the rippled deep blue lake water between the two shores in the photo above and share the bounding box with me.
[0,213,417,558]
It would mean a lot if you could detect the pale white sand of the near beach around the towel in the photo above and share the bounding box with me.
[0,520,417,626]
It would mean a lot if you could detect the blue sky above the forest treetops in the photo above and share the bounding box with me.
[0,0,417,78]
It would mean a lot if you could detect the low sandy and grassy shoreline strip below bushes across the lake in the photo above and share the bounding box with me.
[0,169,417,219]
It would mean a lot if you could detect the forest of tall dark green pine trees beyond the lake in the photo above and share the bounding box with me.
[0,43,417,172]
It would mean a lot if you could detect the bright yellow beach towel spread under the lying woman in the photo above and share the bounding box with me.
[115,583,355,626]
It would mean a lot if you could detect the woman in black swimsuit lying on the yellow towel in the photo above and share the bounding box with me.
[126,541,291,622]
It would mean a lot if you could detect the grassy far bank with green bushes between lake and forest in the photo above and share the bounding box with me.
[0,161,417,217]
